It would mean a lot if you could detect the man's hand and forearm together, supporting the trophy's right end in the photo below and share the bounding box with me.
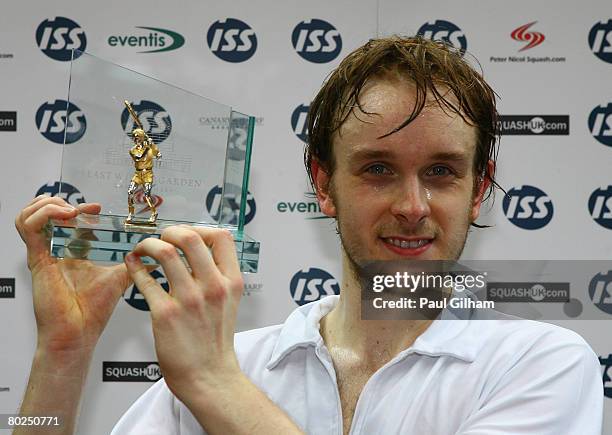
[125,226,302,435]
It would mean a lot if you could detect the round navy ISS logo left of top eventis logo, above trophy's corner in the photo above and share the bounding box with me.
[36,17,87,62]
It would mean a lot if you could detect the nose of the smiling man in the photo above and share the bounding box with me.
[391,179,431,225]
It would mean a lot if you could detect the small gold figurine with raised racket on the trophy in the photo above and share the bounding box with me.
[123,100,161,225]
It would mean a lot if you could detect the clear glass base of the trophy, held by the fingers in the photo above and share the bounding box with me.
[51,213,259,273]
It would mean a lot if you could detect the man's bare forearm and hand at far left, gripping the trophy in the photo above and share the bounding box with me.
[14,196,130,435]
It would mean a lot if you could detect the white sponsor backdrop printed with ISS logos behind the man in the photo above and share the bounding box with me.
[0,0,612,434]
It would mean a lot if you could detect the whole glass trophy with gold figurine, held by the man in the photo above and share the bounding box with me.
[51,50,259,272]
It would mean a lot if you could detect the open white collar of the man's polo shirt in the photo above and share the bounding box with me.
[266,295,482,370]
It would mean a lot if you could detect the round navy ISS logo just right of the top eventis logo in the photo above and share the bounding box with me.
[206,18,257,63]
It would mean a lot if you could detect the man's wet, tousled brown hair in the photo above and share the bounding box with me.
[304,36,498,209]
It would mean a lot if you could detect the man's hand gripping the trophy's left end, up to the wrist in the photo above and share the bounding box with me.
[15,196,130,356]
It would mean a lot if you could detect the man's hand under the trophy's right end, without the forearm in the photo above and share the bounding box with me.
[126,226,243,401]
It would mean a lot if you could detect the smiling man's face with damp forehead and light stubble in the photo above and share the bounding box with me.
[317,80,486,264]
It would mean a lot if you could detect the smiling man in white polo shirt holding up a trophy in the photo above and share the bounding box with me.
[17,37,603,435]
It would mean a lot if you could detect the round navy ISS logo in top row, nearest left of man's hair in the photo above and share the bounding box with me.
[291,18,342,63]
